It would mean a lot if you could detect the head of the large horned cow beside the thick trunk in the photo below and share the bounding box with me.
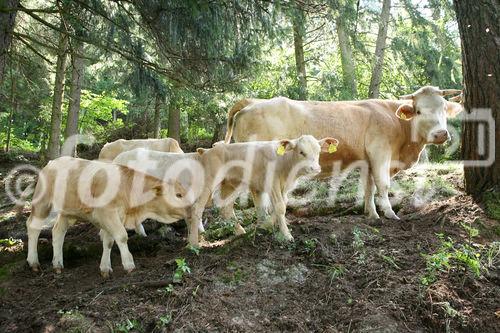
[396,86,462,144]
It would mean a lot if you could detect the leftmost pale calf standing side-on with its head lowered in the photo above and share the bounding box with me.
[26,157,189,277]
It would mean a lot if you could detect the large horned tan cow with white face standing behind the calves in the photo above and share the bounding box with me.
[225,86,462,219]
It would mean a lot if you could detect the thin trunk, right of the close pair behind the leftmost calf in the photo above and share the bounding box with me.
[64,40,85,153]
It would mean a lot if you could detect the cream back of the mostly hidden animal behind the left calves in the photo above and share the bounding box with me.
[99,138,183,161]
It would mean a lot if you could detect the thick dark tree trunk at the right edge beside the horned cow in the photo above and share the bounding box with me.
[454,0,500,199]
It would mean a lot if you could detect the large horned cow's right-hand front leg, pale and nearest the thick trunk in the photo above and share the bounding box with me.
[371,155,399,220]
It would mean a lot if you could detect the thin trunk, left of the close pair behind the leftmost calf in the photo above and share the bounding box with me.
[47,25,68,160]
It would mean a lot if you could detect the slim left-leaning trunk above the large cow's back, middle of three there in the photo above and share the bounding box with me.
[336,13,358,98]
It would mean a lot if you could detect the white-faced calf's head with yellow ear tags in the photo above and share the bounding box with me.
[278,135,339,174]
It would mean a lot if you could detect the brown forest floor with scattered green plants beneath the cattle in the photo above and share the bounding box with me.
[0,159,500,333]
